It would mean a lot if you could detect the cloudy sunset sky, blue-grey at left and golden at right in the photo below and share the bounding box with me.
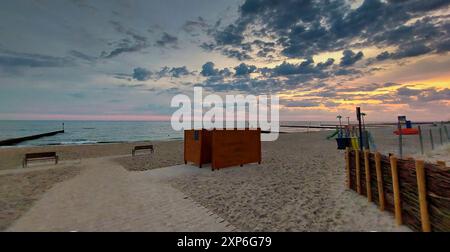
[0,0,450,121]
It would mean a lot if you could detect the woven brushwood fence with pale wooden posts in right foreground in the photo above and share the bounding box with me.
[346,148,450,232]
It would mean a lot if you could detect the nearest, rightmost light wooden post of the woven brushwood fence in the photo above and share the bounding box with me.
[416,160,431,232]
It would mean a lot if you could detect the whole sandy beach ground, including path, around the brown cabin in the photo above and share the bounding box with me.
[0,128,449,231]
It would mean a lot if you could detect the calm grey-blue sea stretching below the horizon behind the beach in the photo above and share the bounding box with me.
[0,120,332,146]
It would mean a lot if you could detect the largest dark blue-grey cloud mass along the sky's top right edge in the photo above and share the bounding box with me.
[209,0,450,60]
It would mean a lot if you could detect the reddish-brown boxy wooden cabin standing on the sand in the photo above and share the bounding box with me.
[184,128,261,170]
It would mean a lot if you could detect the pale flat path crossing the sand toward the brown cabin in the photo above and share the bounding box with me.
[7,158,235,231]
